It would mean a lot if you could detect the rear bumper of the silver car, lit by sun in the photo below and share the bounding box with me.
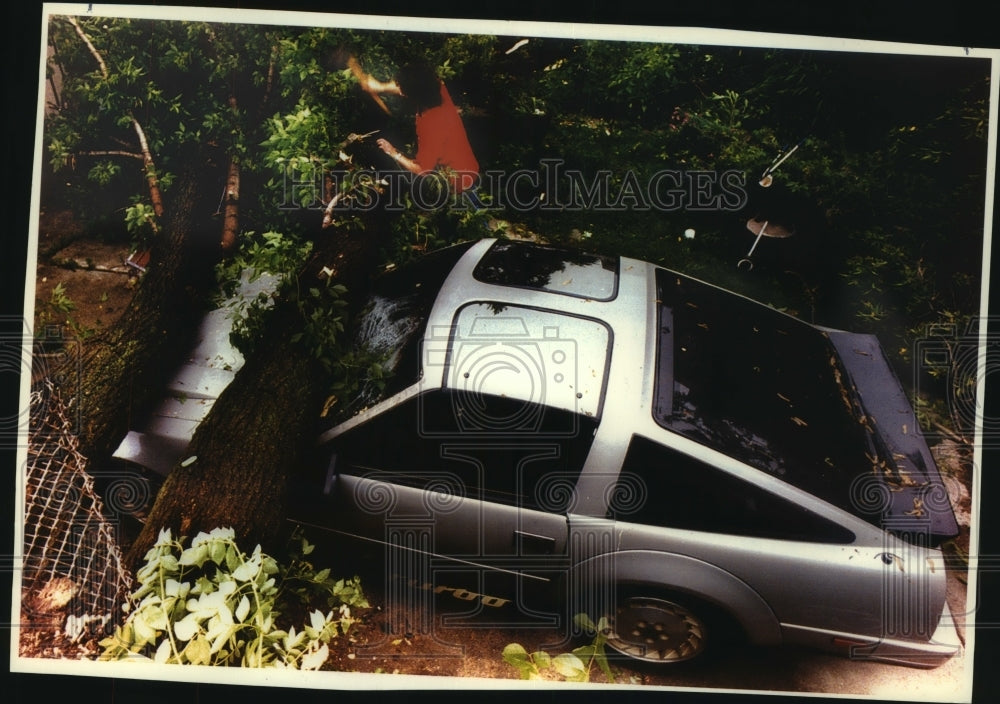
[781,604,962,668]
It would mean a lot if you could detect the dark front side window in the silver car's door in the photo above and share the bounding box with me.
[333,390,597,513]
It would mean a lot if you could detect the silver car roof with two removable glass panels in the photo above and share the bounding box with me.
[424,239,651,416]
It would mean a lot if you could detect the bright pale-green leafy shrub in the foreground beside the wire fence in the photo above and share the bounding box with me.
[100,528,368,670]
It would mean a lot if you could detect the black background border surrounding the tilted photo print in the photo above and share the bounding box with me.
[0,0,1000,704]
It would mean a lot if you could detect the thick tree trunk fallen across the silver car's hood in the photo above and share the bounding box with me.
[126,226,383,569]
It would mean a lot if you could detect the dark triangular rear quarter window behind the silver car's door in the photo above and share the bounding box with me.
[611,435,854,543]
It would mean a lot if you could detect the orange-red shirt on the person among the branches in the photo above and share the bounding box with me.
[414,83,479,191]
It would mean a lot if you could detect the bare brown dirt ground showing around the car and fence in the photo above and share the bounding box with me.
[22,213,972,701]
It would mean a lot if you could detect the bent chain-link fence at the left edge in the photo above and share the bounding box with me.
[21,383,131,642]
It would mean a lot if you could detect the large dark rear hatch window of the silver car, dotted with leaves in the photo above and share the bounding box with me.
[653,270,878,518]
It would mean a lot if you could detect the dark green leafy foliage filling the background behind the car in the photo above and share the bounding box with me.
[46,18,989,428]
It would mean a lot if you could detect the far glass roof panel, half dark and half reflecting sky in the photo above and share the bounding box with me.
[473,240,618,301]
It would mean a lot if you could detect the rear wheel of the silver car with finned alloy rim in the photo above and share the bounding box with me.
[605,595,712,664]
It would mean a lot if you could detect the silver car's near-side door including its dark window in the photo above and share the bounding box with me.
[312,390,597,610]
